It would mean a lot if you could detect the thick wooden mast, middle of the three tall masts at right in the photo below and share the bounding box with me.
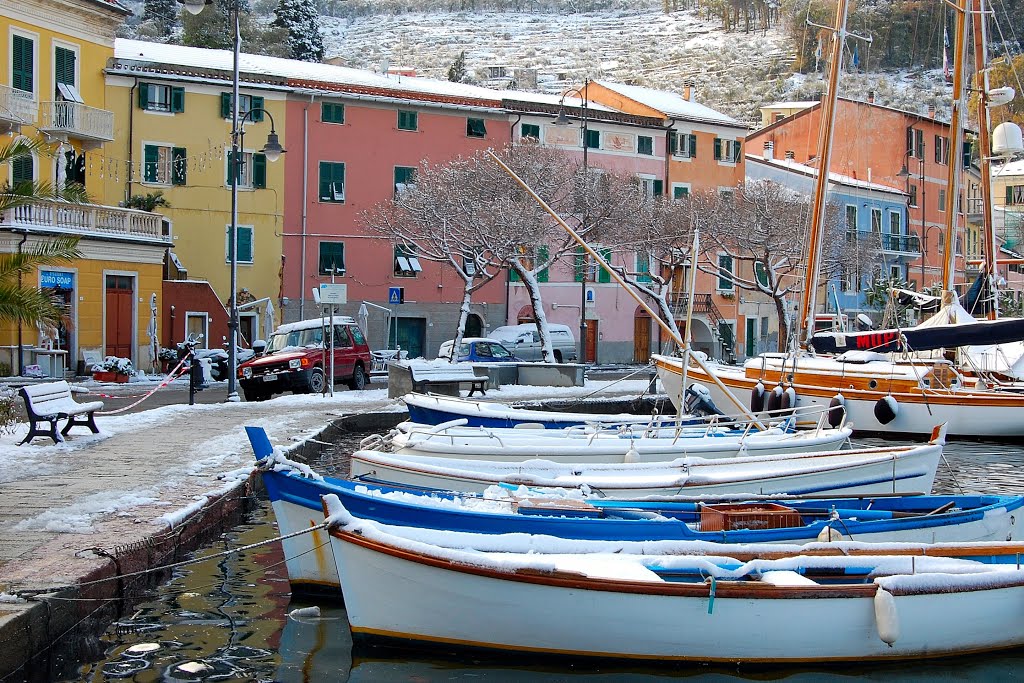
[942,0,968,306]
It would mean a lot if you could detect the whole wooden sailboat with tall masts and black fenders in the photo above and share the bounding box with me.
[653,0,1024,437]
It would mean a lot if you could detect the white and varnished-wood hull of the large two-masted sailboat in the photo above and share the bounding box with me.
[655,356,1024,438]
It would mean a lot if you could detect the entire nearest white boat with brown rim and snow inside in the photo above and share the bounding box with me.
[325,496,1024,663]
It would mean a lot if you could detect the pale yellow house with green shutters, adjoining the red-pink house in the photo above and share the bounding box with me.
[105,40,289,347]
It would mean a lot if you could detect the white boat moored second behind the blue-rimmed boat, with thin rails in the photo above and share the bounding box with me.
[361,420,853,463]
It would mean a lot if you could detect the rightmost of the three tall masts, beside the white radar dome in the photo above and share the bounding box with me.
[971,0,999,321]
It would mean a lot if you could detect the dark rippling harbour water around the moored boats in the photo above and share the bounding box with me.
[59,434,1024,683]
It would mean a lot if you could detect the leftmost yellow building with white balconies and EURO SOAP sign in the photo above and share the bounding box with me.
[0,0,169,376]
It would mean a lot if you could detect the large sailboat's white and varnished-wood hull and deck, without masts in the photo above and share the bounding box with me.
[652,352,1024,437]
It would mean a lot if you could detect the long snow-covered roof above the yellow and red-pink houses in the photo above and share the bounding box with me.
[110,39,502,106]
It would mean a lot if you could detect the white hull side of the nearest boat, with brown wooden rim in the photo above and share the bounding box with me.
[332,532,1024,664]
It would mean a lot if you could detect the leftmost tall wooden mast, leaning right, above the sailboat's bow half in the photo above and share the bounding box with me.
[797,0,849,348]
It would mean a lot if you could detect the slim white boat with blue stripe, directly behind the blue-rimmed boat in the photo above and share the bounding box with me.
[351,430,943,499]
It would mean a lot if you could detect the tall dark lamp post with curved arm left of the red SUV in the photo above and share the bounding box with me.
[177,0,285,401]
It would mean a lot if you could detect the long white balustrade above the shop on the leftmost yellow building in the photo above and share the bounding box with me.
[0,201,170,244]
